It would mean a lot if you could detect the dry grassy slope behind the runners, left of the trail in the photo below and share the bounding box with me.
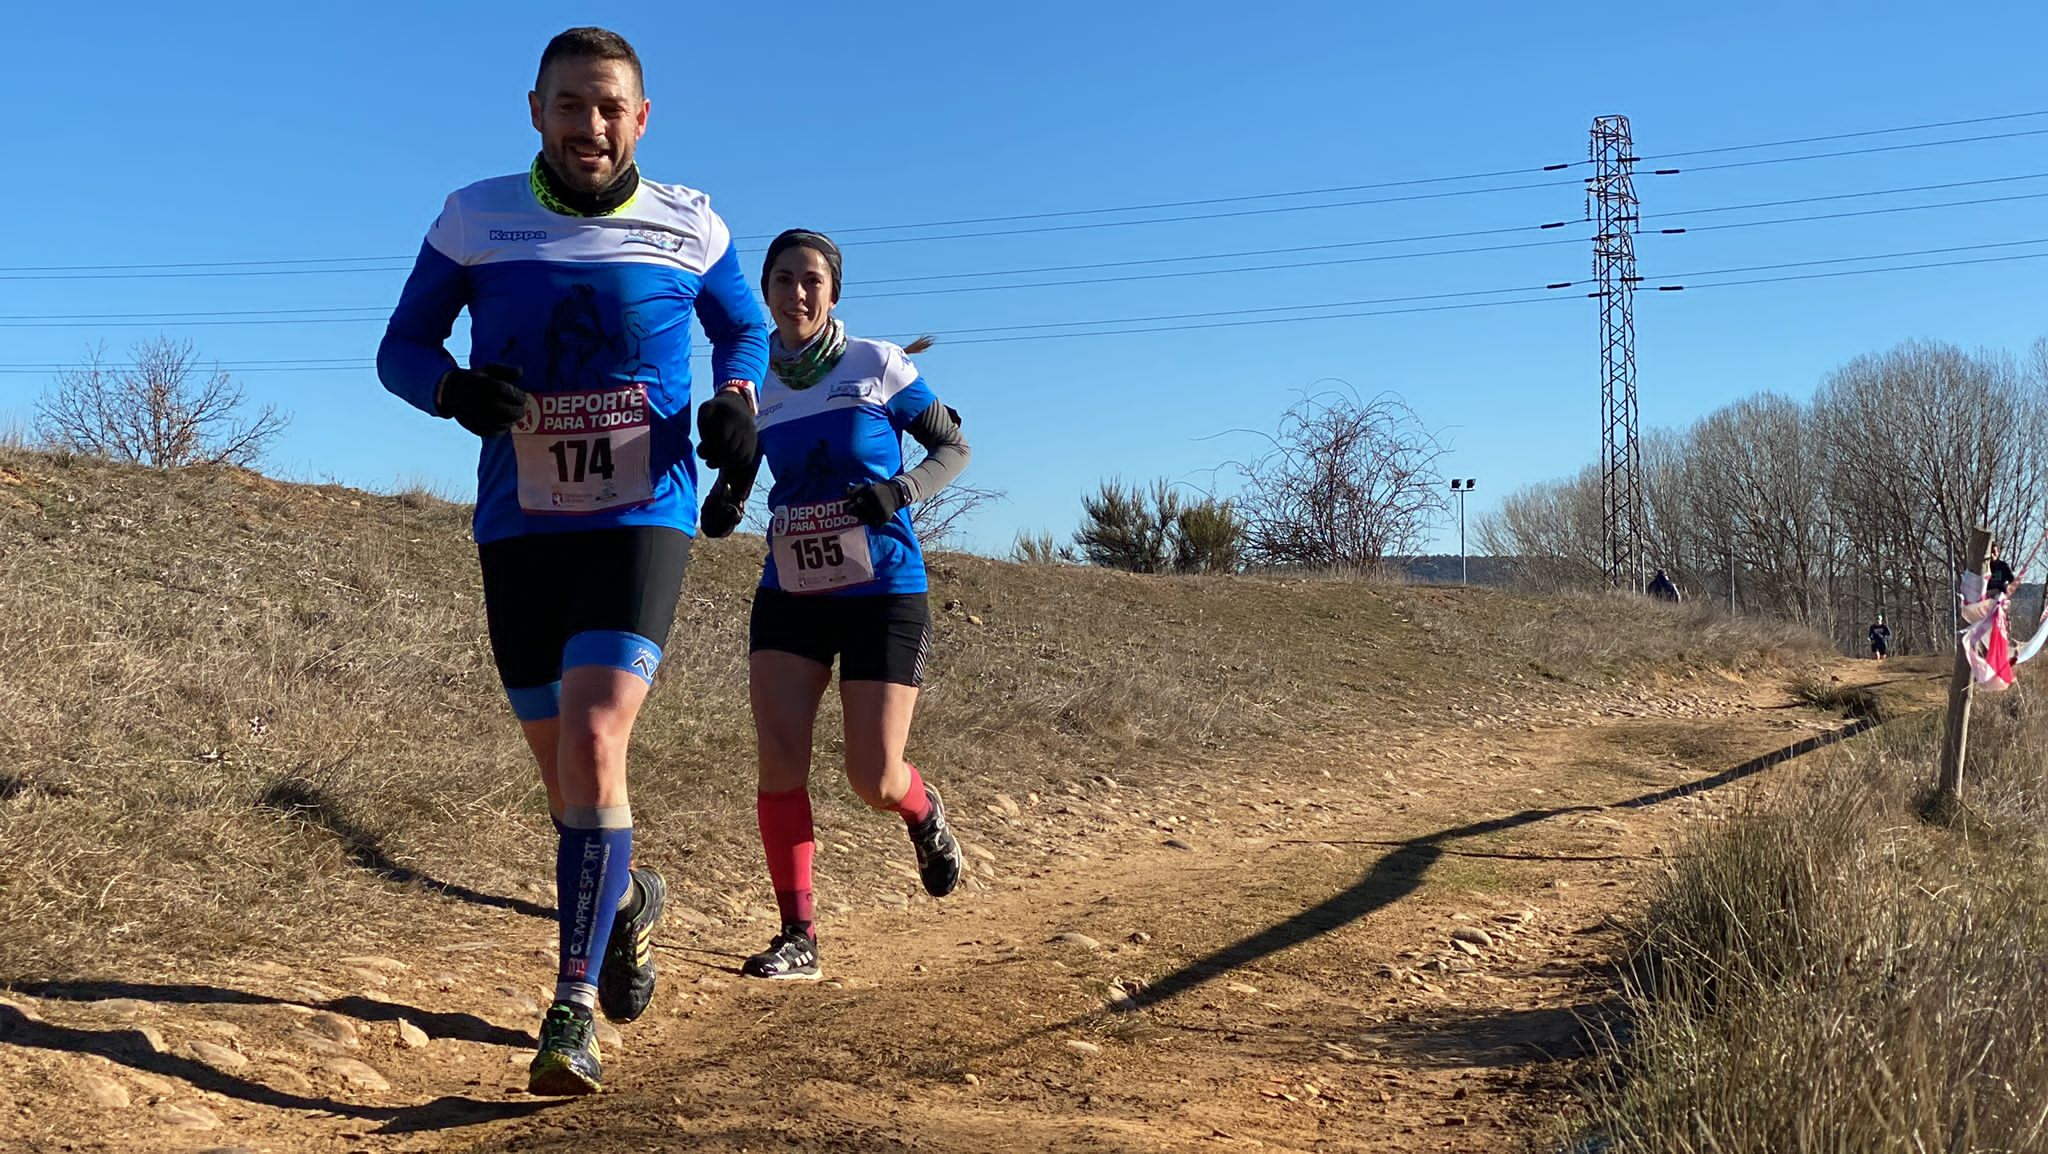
[0,451,1810,984]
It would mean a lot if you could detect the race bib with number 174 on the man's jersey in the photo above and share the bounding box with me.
[512,385,653,512]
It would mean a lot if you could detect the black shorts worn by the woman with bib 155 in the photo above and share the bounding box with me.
[748,588,932,689]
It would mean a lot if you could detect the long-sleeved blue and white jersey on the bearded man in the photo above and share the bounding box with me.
[377,172,768,543]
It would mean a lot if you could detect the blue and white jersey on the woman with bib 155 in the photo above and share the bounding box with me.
[760,336,938,596]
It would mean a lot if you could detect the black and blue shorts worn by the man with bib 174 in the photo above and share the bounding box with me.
[477,525,690,707]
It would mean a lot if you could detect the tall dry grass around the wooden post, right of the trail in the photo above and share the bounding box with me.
[1589,693,2048,1154]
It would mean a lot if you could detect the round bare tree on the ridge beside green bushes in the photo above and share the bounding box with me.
[1235,391,1450,570]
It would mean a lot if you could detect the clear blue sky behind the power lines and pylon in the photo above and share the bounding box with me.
[0,0,2048,551]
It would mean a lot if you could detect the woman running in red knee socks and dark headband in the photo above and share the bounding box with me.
[724,230,967,980]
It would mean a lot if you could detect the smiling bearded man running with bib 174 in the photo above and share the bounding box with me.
[377,29,768,1095]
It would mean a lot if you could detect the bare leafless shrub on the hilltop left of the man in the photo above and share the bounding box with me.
[35,336,289,469]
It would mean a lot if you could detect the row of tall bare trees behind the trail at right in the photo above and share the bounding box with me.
[1479,338,2048,652]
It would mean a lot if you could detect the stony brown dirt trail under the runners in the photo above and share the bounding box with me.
[0,662,1939,1154]
